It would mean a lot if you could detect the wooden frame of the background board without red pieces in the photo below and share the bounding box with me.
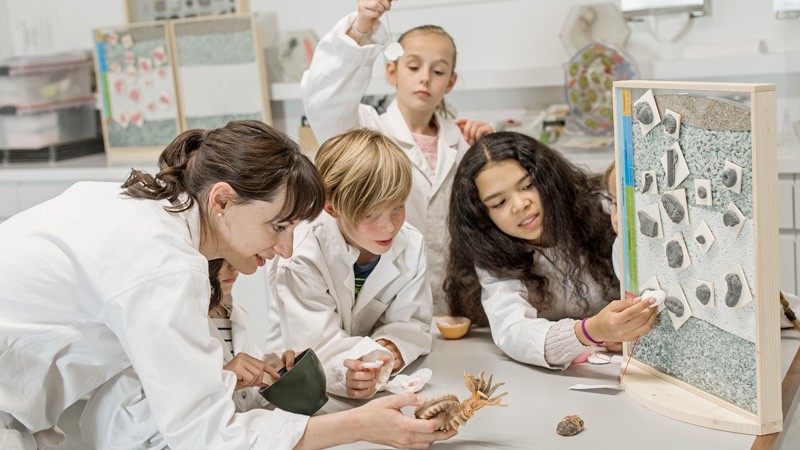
[168,14,272,130]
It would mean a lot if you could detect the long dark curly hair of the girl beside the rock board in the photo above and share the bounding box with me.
[444,132,618,325]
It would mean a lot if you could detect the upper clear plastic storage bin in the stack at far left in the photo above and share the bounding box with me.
[0,53,92,109]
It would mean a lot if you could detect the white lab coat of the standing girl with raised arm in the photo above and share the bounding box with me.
[301,14,469,312]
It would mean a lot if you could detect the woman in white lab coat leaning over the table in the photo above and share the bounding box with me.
[0,121,452,448]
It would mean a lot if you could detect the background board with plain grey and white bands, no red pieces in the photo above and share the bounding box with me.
[169,15,272,130]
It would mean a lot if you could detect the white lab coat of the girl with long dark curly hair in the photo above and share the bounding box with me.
[476,249,618,369]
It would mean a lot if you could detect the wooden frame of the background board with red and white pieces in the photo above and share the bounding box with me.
[93,22,182,165]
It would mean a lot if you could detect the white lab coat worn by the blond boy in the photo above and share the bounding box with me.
[268,212,432,396]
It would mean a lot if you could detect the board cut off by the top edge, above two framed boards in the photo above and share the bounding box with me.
[125,0,250,23]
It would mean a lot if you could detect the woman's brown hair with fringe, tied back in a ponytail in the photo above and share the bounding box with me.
[122,120,325,222]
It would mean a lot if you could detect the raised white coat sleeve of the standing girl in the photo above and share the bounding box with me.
[300,5,391,142]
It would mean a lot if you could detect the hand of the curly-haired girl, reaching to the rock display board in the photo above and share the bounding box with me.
[575,297,658,346]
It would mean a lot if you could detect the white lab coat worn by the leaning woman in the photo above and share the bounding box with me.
[0,183,308,448]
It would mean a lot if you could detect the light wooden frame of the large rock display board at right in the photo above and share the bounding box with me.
[613,81,783,435]
